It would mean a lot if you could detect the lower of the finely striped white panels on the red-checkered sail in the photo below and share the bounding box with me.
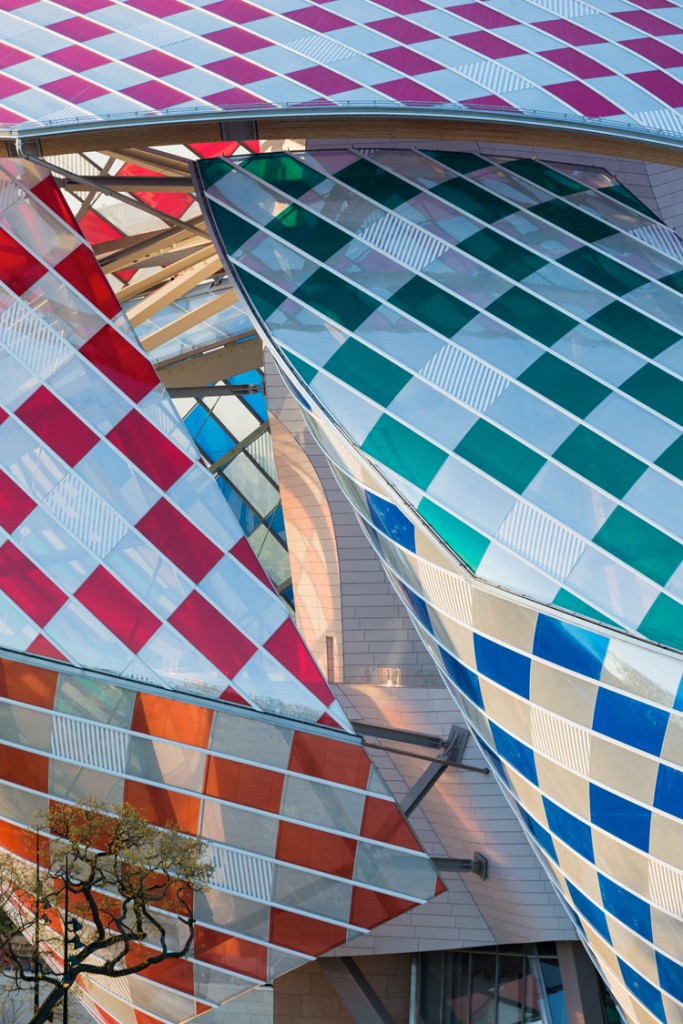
[45,473,128,558]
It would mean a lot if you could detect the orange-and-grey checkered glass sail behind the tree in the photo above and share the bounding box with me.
[0,657,443,1024]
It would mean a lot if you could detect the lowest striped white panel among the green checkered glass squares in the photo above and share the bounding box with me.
[496,501,586,580]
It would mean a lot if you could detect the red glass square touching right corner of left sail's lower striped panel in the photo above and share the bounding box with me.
[137,498,223,583]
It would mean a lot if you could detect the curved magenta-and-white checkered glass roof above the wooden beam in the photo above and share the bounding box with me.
[0,0,683,140]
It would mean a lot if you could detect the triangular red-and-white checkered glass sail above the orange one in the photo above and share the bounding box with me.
[0,161,349,729]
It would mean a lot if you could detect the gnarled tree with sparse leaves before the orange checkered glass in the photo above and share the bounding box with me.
[0,802,213,1024]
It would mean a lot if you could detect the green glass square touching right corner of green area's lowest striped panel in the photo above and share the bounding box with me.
[593,506,683,586]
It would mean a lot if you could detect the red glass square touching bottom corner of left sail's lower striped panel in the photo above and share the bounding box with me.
[75,565,161,653]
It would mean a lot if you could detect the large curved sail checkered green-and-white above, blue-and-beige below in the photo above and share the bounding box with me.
[201,151,683,1024]
